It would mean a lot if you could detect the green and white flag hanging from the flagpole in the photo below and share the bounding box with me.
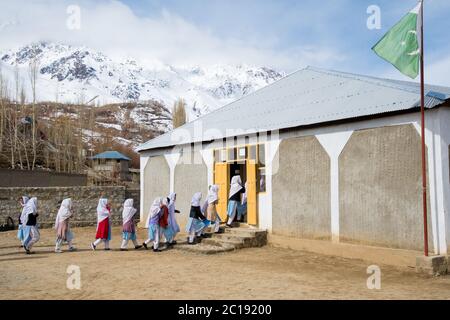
[372,1,422,79]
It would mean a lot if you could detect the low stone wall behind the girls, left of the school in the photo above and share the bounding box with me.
[0,187,139,228]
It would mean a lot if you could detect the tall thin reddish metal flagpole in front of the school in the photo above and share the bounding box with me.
[420,0,428,257]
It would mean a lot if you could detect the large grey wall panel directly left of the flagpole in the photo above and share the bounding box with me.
[339,125,433,250]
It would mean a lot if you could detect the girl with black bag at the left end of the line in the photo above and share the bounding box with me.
[20,197,41,254]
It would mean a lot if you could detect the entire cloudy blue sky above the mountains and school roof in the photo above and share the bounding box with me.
[0,0,450,86]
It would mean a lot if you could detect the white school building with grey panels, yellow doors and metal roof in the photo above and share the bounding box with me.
[139,67,450,254]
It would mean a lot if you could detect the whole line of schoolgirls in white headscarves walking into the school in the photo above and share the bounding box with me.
[17,176,246,254]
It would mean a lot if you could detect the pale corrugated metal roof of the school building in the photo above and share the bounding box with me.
[138,67,450,151]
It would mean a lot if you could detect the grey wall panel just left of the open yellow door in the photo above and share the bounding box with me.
[174,152,208,228]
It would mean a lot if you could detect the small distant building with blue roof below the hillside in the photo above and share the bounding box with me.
[89,151,132,185]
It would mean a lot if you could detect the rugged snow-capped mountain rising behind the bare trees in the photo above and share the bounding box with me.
[0,42,284,120]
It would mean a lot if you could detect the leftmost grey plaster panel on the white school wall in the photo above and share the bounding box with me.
[141,156,170,226]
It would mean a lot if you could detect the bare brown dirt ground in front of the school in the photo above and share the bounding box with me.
[0,228,450,300]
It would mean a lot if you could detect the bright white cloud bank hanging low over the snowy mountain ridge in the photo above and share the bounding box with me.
[0,0,344,71]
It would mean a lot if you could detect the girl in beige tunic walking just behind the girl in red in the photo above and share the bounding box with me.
[55,198,75,253]
